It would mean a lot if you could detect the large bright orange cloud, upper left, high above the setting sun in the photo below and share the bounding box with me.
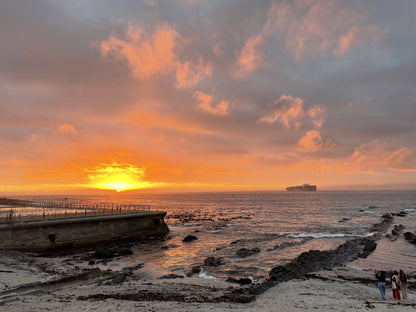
[96,24,213,88]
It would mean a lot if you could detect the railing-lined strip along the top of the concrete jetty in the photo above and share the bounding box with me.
[0,202,150,223]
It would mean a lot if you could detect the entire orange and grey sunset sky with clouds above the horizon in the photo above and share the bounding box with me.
[0,0,416,195]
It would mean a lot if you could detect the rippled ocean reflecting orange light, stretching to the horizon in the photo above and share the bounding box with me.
[11,191,416,282]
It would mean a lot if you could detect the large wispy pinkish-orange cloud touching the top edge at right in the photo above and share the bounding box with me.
[236,0,389,69]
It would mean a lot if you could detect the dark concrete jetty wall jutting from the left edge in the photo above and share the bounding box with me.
[0,212,169,251]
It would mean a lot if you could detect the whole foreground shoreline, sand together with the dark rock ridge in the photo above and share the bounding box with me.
[0,211,416,311]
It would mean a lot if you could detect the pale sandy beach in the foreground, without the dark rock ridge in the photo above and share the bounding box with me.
[0,245,416,312]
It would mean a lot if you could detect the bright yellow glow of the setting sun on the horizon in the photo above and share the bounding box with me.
[86,162,153,192]
